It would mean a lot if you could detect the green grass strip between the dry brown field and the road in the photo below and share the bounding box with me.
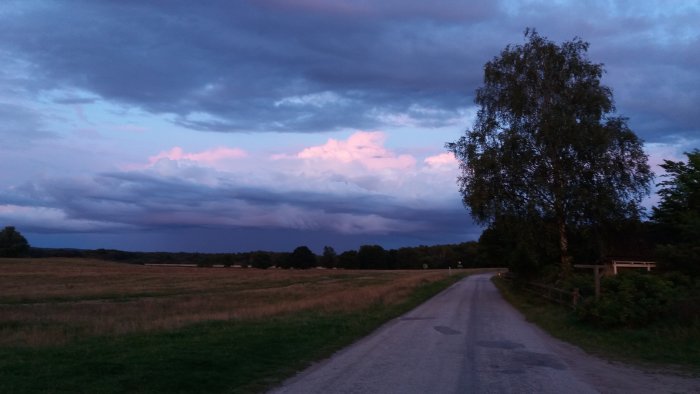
[0,275,464,393]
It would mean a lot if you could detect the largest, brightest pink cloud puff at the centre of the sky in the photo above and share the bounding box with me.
[296,131,416,170]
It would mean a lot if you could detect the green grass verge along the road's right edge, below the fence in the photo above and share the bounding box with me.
[493,277,700,375]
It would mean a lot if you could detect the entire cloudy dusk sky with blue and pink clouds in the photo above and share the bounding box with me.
[0,0,700,253]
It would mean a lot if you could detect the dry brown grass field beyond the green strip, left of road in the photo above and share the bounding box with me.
[0,258,476,347]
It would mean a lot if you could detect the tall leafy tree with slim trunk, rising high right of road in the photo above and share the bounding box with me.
[447,29,652,271]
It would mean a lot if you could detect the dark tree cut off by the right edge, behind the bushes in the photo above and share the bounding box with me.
[652,149,700,276]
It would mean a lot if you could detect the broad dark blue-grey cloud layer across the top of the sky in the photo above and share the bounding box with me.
[2,0,700,140]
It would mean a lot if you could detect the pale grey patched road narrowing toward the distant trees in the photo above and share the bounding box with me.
[272,274,700,394]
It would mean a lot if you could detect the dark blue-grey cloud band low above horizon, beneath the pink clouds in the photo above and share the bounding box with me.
[0,169,478,242]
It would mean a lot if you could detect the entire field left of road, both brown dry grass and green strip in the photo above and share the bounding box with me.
[0,259,486,393]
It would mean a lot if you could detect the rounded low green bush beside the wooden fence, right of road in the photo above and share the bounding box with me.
[577,272,677,327]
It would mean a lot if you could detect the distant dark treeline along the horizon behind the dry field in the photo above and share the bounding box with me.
[29,241,486,269]
